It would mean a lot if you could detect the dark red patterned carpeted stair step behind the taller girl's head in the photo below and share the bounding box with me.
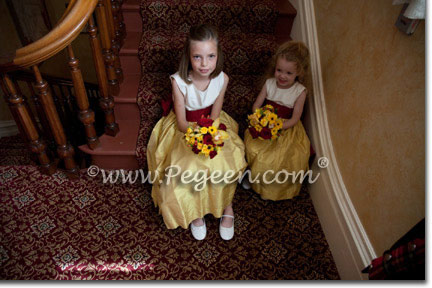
[138,30,278,75]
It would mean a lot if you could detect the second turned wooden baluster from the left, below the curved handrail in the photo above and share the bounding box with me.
[33,65,79,178]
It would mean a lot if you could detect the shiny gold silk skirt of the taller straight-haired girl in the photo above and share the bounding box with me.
[147,111,247,229]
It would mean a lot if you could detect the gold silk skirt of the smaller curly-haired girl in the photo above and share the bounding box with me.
[245,121,310,201]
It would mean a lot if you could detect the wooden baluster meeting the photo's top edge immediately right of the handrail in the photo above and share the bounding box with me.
[95,0,120,96]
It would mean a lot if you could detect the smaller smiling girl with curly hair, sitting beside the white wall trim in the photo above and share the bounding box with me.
[243,41,310,200]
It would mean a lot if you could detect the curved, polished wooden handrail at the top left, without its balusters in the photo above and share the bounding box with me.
[0,0,98,72]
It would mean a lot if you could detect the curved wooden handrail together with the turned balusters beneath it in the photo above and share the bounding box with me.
[0,0,122,178]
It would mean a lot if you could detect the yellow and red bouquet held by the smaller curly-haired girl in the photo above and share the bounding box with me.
[248,105,283,140]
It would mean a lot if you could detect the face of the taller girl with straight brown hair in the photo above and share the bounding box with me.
[190,40,218,77]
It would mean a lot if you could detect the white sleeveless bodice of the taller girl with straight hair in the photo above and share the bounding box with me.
[170,72,224,111]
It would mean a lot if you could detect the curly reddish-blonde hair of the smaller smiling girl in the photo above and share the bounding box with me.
[264,41,310,88]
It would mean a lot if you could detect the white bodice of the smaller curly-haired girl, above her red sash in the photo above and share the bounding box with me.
[265,78,306,108]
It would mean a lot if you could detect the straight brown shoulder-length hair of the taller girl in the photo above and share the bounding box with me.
[179,24,224,84]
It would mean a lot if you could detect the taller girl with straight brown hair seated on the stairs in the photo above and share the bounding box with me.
[147,25,247,240]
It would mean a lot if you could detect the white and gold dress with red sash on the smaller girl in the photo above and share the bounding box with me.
[245,78,310,201]
